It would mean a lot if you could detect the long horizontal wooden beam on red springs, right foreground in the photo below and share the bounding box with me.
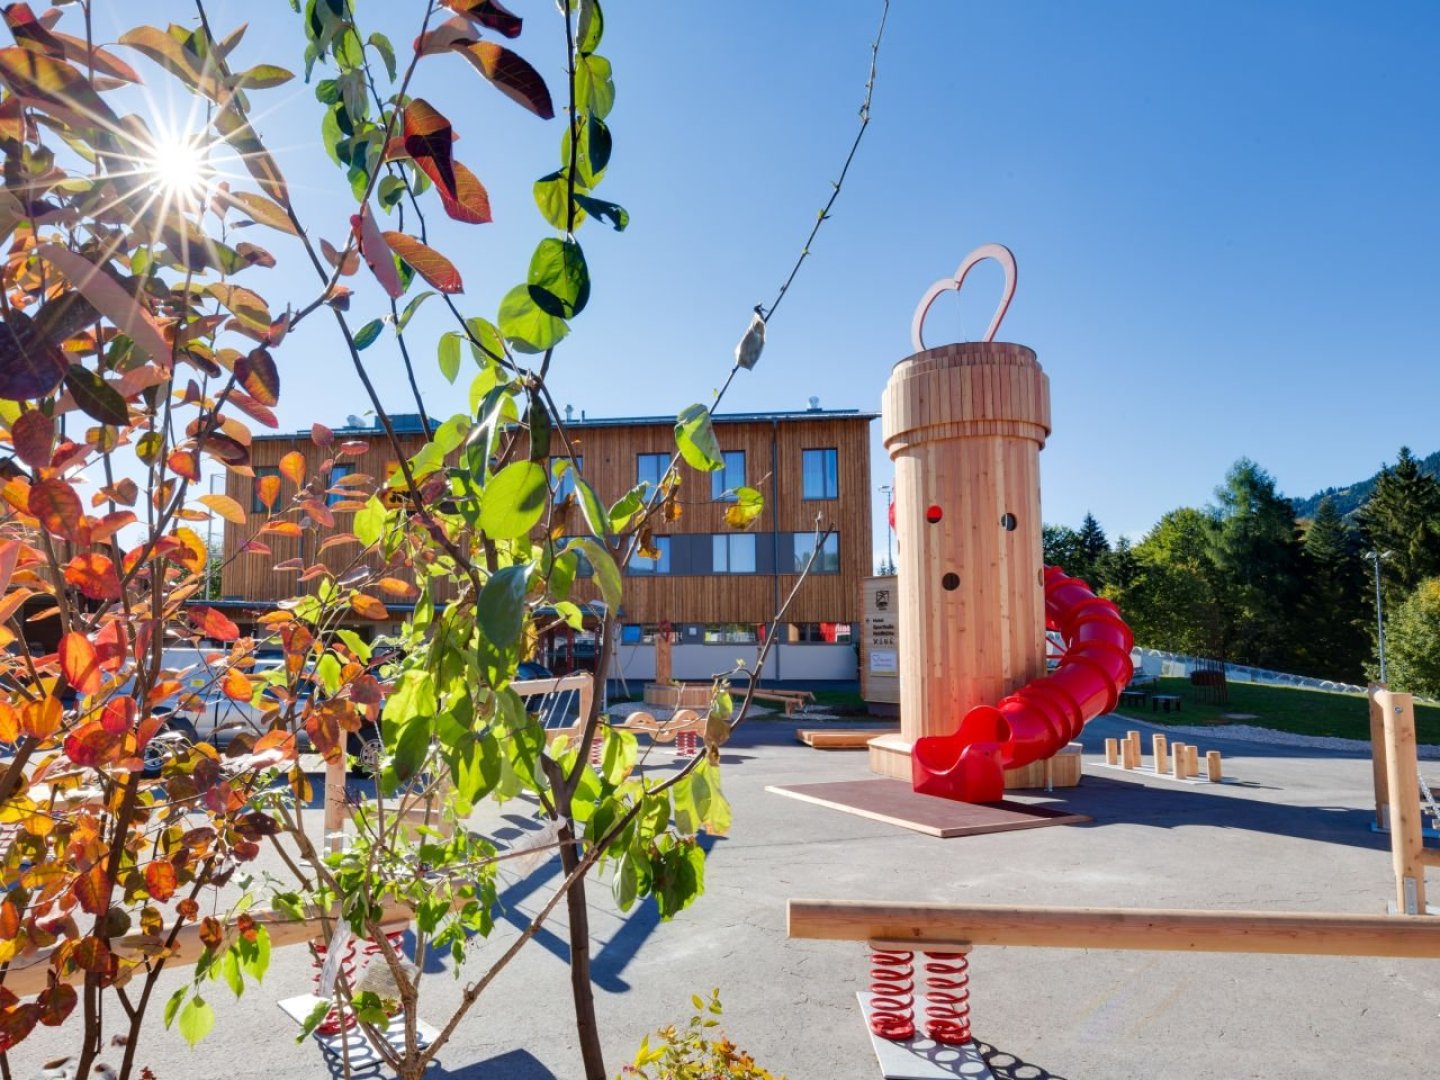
[789,900,1440,959]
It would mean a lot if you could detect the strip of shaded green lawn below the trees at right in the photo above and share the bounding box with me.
[1115,678,1440,743]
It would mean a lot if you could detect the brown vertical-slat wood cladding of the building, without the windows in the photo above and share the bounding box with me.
[222,412,873,625]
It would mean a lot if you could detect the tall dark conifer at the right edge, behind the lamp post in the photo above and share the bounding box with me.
[1355,446,1440,608]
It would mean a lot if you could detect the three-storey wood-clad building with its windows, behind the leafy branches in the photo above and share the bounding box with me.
[210,408,874,679]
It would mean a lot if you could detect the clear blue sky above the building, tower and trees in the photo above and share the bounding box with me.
[98,0,1440,567]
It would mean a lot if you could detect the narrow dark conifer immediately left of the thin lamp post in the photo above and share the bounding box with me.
[1296,495,1374,683]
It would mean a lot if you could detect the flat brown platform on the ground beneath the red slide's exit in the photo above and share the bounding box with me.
[766,779,1090,838]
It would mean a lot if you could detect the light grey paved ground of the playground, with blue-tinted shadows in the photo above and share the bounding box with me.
[12,717,1440,1080]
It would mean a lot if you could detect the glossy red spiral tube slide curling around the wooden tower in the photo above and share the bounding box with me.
[910,566,1135,802]
